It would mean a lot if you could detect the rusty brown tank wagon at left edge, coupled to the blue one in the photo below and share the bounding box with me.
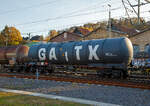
[0,45,29,72]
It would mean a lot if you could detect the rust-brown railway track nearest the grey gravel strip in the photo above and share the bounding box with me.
[0,73,150,89]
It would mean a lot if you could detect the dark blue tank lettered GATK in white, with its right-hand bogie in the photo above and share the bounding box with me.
[28,37,133,77]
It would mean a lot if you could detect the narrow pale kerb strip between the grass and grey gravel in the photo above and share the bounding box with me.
[0,88,120,106]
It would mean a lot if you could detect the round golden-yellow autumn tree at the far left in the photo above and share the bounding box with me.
[0,26,22,45]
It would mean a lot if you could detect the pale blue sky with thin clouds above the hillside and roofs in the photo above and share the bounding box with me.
[0,0,150,36]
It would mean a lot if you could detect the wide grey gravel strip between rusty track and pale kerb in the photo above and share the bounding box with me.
[0,77,150,106]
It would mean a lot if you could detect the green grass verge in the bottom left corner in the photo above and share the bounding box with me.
[0,92,87,106]
